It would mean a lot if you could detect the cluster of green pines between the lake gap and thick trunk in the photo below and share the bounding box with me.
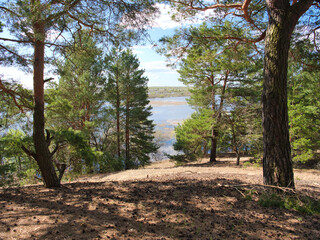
[162,22,262,163]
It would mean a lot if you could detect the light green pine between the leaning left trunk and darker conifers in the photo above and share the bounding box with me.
[46,34,106,172]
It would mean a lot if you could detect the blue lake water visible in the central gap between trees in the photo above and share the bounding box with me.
[150,97,194,160]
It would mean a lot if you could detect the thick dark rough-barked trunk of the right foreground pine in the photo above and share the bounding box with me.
[262,1,295,188]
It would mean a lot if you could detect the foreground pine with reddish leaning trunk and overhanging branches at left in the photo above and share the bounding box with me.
[0,0,154,187]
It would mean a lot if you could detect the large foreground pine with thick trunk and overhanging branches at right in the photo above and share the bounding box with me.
[158,0,320,188]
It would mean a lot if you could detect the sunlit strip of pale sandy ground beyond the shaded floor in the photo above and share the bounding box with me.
[80,158,320,191]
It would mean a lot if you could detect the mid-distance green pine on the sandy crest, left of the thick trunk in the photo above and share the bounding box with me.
[178,23,253,162]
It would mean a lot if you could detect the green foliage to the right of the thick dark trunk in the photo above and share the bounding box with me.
[288,40,320,163]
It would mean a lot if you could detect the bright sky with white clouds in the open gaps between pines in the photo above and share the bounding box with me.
[0,4,212,89]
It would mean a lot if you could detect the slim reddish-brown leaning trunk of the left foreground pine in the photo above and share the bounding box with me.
[33,21,60,188]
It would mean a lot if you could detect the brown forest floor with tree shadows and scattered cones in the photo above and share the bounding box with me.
[0,158,320,240]
